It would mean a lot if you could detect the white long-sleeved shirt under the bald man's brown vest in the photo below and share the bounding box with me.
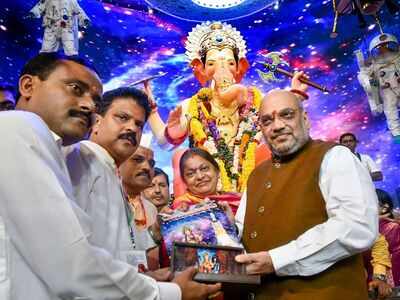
[236,146,378,276]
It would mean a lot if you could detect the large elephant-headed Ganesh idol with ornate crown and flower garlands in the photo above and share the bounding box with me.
[149,22,307,192]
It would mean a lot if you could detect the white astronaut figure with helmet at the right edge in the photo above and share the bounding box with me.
[355,33,400,143]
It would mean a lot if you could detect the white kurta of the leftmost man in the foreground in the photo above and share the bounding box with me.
[0,111,178,300]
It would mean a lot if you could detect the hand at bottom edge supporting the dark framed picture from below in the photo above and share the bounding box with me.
[173,267,221,300]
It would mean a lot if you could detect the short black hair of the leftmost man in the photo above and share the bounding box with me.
[16,52,99,102]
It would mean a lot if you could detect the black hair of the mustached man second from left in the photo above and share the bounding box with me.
[97,87,151,121]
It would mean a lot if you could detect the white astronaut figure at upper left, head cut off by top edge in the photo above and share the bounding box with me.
[30,0,90,56]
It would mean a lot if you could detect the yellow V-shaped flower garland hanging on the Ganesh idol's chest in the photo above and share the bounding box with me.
[188,88,262,192]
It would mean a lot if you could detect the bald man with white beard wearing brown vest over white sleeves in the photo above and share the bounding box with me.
[236,90,378,300]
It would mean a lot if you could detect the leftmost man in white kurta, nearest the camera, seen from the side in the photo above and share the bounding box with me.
[0,53,165,300]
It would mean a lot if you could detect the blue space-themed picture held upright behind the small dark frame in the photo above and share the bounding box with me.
[160,202,242,256]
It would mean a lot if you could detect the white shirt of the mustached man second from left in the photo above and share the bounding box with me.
[63,141,181,300]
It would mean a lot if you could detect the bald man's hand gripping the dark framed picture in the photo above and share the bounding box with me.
[235,251,275,275]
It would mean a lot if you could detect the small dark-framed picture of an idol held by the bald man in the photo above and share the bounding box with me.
[171,242,261,284]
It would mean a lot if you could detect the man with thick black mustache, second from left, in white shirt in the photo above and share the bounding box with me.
[64,87,219,300]
